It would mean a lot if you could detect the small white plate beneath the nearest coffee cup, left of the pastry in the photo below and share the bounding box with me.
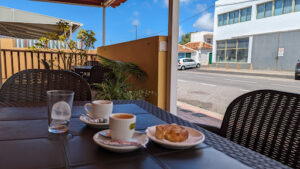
[93,129,149,153]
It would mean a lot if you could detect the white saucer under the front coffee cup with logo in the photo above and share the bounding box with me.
[93,129,149,153]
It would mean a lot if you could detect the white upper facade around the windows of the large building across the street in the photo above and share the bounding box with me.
[213,0,300,62]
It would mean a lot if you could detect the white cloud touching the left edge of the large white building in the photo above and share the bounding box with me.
[193,13,214,30]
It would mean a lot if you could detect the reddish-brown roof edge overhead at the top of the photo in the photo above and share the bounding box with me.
[33,0,127,8]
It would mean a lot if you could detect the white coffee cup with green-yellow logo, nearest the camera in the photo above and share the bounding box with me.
[109,113,136,141]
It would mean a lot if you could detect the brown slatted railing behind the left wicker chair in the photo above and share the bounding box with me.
[0,49,96,82]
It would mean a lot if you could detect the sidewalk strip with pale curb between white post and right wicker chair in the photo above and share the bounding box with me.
[177,101,223,128]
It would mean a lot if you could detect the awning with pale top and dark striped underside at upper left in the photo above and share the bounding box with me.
[0,7,82,39]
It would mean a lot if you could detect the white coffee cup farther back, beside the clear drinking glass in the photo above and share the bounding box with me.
[84,100,113,119]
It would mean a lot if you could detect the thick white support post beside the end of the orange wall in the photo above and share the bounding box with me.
[166,0,179,115]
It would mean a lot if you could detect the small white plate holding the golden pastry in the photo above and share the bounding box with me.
[146,126,205,149]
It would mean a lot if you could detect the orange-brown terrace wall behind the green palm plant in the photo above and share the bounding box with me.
[97,36,168,109]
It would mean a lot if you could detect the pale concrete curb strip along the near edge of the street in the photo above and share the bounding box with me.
[177,101,223,120]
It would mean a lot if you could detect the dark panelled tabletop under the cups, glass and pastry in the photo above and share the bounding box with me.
[0,101,288,169]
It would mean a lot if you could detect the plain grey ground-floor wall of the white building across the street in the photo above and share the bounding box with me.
[252,31,300,71]
